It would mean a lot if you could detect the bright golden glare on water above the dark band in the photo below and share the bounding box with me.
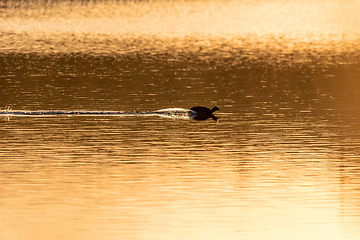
[0,0,360,53]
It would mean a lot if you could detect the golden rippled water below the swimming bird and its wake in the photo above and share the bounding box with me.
[0,117,359,239]
